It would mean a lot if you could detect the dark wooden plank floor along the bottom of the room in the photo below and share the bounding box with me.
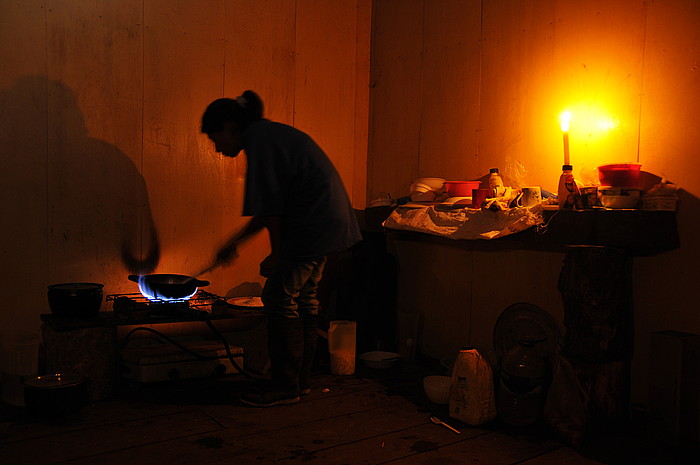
[0,365,700,465]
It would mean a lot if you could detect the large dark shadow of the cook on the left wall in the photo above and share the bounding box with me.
[0,76,160,282]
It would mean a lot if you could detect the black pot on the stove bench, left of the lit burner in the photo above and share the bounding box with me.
[48,283,104,318]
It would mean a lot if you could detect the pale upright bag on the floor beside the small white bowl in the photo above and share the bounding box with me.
[449,348,496,426]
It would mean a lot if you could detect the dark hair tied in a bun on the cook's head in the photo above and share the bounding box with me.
[202,90,263,134]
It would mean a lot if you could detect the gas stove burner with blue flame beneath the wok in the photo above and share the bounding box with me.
[105,289,225,319]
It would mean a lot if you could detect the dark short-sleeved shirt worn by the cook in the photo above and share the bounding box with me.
[243,120,362,260]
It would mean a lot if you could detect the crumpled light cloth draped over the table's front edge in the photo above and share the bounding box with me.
[383,204,544,239]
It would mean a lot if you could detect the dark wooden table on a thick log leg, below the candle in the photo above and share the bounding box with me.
[387,209,680,436]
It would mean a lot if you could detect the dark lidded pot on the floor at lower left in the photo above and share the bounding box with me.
[24,374,88,417]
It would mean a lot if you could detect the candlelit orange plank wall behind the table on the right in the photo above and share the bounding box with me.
[368,0,700,399]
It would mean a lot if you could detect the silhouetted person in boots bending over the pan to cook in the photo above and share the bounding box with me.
[201,90,361,407]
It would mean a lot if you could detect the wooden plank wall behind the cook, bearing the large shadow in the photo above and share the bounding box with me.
[0,0,371,331]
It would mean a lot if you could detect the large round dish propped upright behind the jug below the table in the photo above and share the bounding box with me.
[493,303,561,358]
